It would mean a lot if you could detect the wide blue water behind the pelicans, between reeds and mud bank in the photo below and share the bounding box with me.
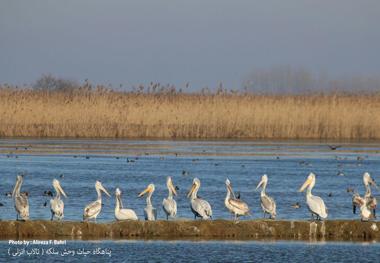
[0,139,380,221]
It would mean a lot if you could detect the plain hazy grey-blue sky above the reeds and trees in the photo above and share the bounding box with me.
[0,0,380,89]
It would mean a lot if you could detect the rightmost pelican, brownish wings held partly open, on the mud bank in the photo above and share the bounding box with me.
[352,172,377,218]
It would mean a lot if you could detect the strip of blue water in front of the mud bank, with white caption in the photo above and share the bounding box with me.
[0,241,380,262]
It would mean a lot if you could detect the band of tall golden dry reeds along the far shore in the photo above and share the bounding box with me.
[0,88,380,140]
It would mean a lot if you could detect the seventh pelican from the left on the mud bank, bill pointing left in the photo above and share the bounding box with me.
[187,178,212,219]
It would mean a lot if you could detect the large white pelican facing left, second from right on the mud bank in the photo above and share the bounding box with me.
[299,173,327,220]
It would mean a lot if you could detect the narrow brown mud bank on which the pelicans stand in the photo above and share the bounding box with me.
[0,220,380,241]
